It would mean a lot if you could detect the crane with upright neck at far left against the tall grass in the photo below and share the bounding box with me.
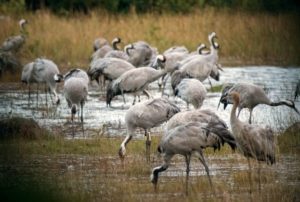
[0,19,27,53]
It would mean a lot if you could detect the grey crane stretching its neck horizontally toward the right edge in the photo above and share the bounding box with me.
[218,83,299,123]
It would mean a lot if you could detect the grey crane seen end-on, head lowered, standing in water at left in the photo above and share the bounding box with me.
[64,75,88,138]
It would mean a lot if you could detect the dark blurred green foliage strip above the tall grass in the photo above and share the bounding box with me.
[0,0,300,15]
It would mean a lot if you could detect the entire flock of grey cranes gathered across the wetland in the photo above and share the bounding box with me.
[0,20,300,193]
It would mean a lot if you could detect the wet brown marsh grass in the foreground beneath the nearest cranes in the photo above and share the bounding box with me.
[0,129,299,202]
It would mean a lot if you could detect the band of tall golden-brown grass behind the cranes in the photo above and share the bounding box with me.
[0,8,300,77]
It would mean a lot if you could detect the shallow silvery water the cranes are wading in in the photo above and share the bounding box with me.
[0,66,300,138]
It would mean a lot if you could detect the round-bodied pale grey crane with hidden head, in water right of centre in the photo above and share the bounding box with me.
[174,79,207,109]
